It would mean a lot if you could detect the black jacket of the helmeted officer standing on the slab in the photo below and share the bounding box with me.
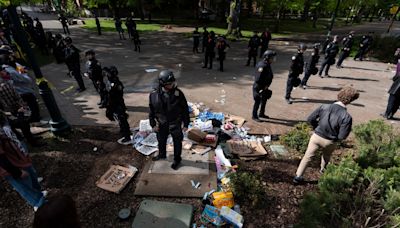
[149,88,190,128]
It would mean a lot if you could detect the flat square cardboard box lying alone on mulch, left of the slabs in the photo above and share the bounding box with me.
[96,165,138,193]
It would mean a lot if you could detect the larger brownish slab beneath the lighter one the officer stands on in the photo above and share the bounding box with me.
[135,151,217,198]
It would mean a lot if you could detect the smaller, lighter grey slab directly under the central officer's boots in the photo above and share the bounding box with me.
[149,150,209,175]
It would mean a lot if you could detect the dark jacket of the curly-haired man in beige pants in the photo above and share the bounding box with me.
[307,103,353,141]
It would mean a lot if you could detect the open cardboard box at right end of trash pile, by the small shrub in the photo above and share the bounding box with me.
[226,140,268,157]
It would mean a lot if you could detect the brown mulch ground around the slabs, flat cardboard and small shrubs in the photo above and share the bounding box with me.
[0,126,350,227]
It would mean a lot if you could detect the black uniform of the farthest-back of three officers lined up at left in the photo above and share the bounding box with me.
[64,44,86,91]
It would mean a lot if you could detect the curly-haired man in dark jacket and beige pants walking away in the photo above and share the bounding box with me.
[293,87,359,184]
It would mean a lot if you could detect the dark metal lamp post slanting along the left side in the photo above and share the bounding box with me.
[7,5,71,135]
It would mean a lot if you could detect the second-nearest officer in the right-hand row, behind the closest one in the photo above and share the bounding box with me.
[285,44,307,104]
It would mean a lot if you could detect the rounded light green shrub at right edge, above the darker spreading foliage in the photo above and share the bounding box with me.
[353,120,400,168]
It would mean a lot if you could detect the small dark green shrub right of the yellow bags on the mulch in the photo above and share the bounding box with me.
[228,171,266,207]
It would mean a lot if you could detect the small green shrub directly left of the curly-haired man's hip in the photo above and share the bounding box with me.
[281,123,312,153]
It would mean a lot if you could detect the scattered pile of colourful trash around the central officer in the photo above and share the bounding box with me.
[132,102,280,227]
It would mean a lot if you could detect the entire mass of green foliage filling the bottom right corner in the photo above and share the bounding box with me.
[297,120,400,227]
